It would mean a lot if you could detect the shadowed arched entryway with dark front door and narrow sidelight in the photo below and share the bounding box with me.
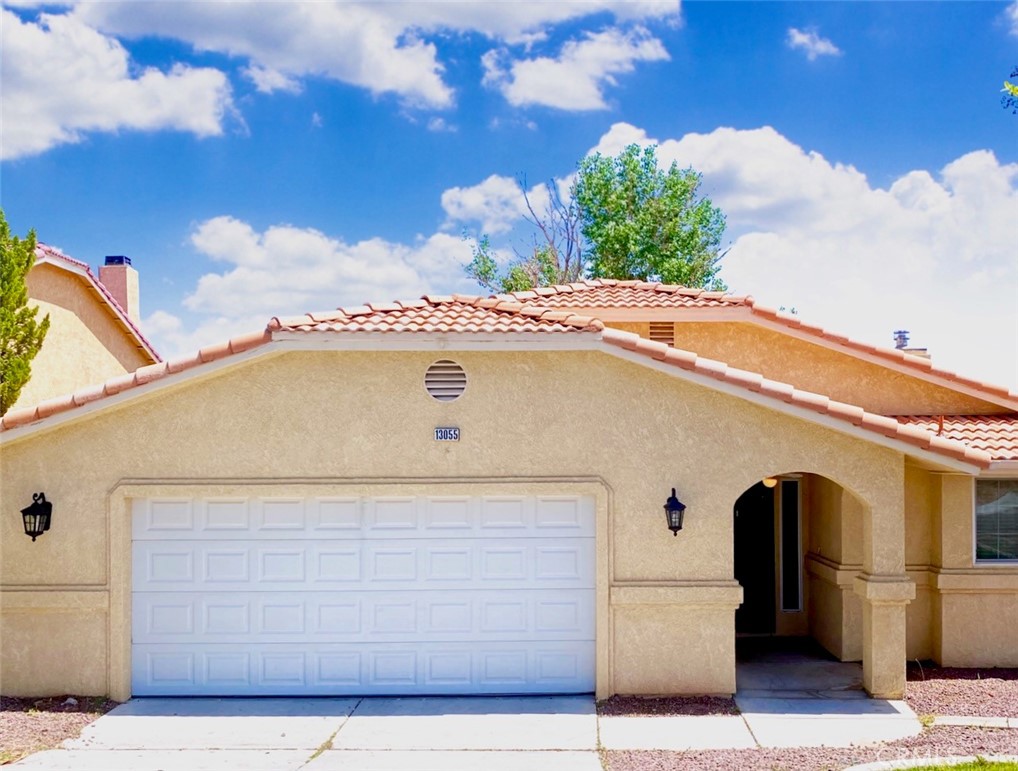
[732,472,864,690]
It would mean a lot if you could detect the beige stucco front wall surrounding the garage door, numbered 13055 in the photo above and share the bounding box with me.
[0,350,924,698]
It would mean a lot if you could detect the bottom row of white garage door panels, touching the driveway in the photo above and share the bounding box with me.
[133,643,593,696]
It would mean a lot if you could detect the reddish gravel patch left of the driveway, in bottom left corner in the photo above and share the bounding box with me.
[0,696,117,765]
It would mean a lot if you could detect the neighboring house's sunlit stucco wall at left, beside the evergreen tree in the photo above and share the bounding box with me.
[13,263,152,409]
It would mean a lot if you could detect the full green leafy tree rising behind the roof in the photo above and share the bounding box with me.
[574,145,725,289]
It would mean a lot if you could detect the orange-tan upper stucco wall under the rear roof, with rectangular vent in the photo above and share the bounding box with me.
[610,322,1007,415]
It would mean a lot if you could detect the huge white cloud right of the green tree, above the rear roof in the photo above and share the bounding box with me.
[599,124,1018,388]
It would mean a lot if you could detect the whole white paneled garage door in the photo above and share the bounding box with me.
[131,496,595,696]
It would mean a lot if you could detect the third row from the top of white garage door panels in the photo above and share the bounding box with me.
[132,590,593,645]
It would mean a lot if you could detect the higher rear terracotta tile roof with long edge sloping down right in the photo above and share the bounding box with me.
[495,279,1018,409]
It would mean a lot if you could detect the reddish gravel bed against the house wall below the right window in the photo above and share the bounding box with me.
[905,662,1018,717]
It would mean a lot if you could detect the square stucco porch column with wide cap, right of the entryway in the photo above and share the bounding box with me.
[855,573,915,699]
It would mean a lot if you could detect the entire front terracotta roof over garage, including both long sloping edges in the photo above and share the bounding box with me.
[0,295,994,467]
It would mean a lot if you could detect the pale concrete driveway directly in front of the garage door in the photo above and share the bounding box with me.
[15,697,601,771]
